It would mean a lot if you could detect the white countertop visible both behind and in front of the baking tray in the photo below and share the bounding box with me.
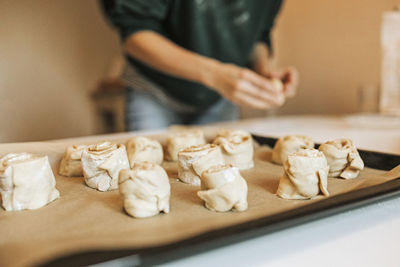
[156,116,400,267]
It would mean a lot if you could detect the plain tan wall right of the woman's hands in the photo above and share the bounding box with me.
[275,0,400,114]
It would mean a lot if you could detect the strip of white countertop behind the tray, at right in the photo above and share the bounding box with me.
[240,115,400,154]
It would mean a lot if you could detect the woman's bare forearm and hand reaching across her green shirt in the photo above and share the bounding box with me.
[125,31,292,109]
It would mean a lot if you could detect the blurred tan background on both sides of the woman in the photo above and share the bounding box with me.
[0,0,399,142]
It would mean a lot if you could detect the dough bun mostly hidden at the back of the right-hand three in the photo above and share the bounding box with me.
[272,135,314,165]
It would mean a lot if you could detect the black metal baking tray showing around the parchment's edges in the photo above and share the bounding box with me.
[40,135,400,266]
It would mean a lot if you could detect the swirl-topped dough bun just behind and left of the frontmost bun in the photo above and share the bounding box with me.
[82,142,129,191]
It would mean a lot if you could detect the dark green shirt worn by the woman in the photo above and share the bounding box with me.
[102,0,282,110]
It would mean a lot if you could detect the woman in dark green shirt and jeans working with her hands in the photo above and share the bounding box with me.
[103,0,297,130]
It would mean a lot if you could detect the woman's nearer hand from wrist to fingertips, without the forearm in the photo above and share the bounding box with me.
[203,62,285,109]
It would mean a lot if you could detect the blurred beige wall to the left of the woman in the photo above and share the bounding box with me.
[0,0,119,142]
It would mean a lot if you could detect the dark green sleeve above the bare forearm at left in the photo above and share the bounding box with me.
[100,0,169,40]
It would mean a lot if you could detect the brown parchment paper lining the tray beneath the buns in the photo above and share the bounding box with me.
[0,135,400,266]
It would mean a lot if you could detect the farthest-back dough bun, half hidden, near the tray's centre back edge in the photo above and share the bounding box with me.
[166,129,206,161]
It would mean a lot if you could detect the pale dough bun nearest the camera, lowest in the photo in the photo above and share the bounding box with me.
[119,162,171,218]
